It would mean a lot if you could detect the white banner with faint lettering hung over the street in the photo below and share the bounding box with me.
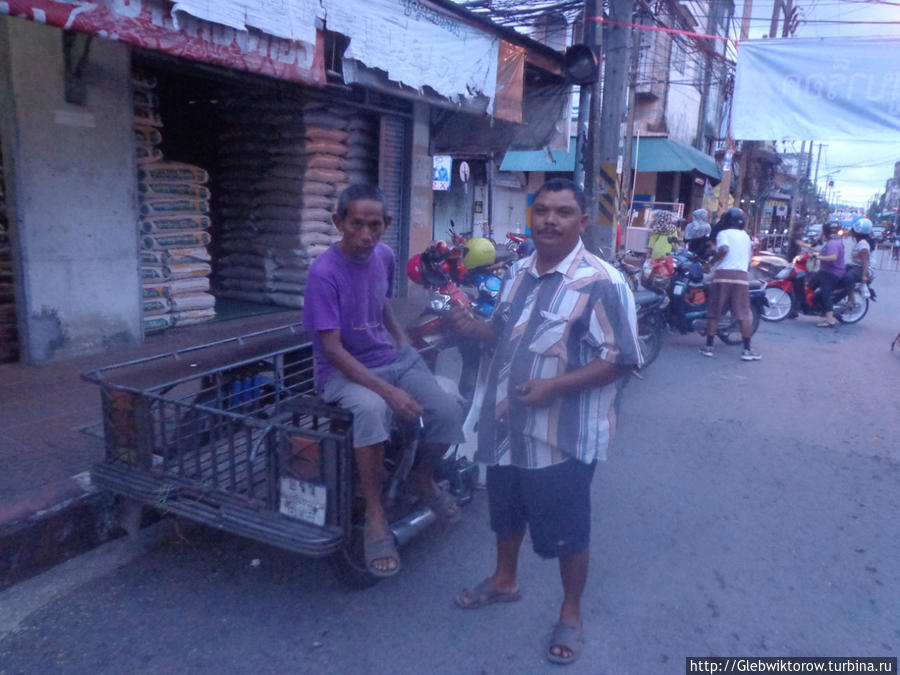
[731,38,900,141]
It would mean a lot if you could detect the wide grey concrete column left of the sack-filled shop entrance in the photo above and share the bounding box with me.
[0,18,141,363]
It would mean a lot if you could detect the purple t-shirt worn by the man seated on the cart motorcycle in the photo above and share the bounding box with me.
[303,243,397,389]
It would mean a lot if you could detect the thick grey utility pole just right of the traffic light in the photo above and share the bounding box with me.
[585,0,634,259]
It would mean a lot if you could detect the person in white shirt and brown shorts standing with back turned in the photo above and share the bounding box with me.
[700,208,762,361]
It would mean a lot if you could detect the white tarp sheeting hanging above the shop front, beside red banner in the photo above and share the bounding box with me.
[172,0,499,109]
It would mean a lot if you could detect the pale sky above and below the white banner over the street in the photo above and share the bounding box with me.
[733,0,900,206]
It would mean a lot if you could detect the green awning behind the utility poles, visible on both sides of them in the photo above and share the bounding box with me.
[500,137,722,180]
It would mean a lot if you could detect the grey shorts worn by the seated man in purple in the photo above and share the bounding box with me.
[323,347,465,448]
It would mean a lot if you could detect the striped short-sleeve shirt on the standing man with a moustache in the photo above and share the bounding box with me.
[476,241,641,469]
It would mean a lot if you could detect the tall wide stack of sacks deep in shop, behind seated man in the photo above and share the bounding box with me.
[215,97,378,308]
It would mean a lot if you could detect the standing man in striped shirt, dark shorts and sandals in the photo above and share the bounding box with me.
[452,179,641,663]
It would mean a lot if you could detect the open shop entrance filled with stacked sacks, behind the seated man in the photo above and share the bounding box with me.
[133,54,408,331]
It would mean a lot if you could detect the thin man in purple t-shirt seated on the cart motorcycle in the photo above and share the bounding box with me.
[303,185,464,576]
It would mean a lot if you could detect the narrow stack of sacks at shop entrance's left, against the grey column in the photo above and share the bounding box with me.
[134,70,215,331]
